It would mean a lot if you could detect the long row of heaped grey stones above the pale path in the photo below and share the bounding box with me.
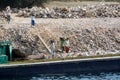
[13,4,120,18]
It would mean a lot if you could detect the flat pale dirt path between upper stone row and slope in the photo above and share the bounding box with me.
[5,14,120,29]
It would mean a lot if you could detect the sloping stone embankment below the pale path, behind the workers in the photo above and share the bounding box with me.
[0,24,120,58]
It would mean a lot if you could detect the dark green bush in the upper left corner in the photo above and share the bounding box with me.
[0,0,49,8]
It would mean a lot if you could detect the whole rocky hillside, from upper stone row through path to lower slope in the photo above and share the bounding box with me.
[0,3,120,55]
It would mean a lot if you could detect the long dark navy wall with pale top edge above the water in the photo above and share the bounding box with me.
[0,56,120,76]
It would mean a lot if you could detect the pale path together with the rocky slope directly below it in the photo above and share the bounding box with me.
[0,18,120,55]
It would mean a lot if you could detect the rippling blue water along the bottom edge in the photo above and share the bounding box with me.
[0,72,120,80]
